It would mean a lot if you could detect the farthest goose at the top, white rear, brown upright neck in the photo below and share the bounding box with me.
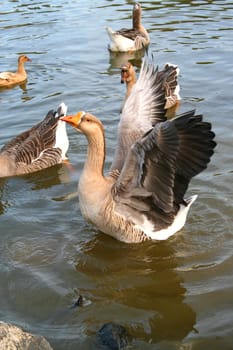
[106,3,150,52]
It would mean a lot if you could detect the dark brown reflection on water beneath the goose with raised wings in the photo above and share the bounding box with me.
[76,237,196,343]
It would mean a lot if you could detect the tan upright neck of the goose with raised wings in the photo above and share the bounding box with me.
[83,128,105,179]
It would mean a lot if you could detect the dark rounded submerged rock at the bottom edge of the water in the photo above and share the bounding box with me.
[98,322,131,350]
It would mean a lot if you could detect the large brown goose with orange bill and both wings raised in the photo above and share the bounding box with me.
[61,59,216,243]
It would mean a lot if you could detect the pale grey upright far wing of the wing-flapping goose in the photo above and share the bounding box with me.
[111,58,166,172]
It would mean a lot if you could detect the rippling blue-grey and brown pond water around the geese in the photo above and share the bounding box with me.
[0,0,233,350]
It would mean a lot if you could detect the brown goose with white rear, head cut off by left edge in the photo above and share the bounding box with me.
[0,103,69,177]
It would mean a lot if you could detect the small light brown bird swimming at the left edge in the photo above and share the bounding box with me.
[0,55,31,87]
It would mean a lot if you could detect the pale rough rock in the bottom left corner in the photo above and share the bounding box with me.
[0,321,53,350]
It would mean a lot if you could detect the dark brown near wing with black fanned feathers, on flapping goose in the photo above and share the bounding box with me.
[113,111,216,216]
